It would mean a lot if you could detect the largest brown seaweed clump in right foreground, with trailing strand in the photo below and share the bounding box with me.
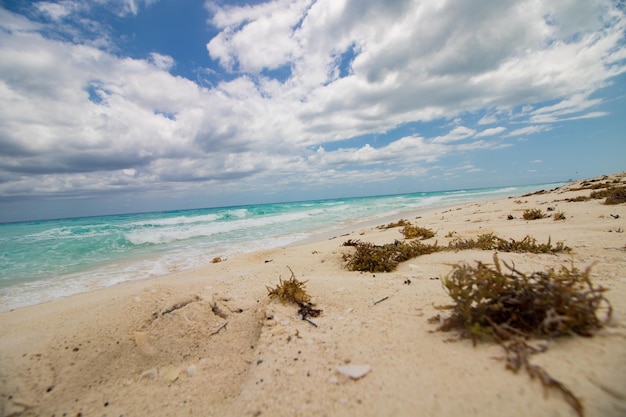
[436,255,612,416]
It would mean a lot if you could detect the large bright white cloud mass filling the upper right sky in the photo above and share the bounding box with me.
[202,0,624,141]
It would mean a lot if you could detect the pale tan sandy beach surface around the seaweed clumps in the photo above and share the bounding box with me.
[0,173,626,417]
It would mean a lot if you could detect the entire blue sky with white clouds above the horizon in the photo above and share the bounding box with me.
[0,0,626,221]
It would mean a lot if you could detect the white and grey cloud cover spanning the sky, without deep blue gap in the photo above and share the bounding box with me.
[0,0,626,205]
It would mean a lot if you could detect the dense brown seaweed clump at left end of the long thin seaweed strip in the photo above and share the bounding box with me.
[343,239,444,272]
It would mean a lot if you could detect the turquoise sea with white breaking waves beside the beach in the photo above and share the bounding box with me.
[0,184,560,311]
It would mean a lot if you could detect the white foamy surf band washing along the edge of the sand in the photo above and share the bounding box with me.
[0,183,562,312]
